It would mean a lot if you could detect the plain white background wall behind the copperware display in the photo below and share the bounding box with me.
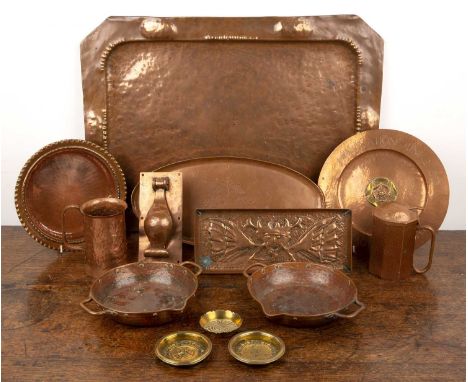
[0,0,468,229]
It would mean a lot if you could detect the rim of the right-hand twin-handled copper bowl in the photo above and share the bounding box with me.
[247,262,357,319]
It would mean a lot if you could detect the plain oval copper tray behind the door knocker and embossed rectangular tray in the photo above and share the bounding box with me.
[132,157,324,244]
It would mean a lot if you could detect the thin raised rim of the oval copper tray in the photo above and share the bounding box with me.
[131,156,325,245]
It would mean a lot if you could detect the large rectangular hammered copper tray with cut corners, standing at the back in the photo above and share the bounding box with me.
[81,15,383,188]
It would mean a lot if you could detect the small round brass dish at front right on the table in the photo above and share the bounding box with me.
[228,330,286,365]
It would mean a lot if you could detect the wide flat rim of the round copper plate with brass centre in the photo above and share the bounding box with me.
[318,129,450,247]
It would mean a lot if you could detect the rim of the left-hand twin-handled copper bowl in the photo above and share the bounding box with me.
[89,261,198,316]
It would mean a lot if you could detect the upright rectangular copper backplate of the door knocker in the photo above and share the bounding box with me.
[138,172,182,263]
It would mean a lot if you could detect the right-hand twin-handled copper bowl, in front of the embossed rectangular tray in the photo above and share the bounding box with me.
[244,262,365,326]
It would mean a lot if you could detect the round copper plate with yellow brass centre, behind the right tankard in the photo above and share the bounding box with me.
[318,130,449,247]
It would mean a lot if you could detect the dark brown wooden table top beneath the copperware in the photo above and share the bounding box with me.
[2,227,465,381]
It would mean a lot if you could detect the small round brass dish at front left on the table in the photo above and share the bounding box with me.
[154,331,212,366]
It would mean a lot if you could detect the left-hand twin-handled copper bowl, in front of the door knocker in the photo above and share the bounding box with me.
[80,261,202,326]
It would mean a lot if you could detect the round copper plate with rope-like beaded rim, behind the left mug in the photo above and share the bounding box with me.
[15,139,126,249]
